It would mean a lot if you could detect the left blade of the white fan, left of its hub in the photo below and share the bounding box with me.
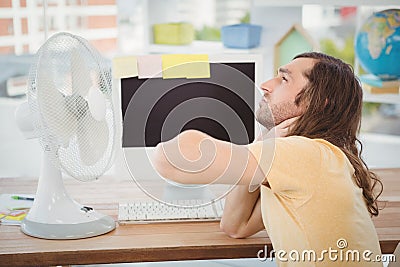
[36,67,77,146]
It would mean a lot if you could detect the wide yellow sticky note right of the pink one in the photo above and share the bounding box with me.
[162,54,210,79]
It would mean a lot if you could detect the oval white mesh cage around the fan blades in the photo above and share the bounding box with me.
[27,32,116,181]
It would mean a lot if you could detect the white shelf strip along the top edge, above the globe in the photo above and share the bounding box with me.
[253,0,400,7]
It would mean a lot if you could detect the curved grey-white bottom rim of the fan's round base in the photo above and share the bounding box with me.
[21,216,115,239]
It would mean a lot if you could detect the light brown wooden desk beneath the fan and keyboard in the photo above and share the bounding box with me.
[0,169,400,266]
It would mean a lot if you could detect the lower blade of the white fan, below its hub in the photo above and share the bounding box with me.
[77,112,109,166]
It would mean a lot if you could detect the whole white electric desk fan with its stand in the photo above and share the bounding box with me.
[16,32,116,239]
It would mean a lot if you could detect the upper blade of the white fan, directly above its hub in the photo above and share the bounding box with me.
[71,50,92,96]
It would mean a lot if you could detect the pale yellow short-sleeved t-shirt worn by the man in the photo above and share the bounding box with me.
[249,136,382,267]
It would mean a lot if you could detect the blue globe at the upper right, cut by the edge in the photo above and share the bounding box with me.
[354,9,400,79]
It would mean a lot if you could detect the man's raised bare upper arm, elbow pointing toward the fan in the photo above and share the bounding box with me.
[152,130,265,186]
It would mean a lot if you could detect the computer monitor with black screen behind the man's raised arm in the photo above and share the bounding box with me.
[119,54,262,201]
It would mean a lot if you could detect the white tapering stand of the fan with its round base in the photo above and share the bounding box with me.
[21,152,115,239]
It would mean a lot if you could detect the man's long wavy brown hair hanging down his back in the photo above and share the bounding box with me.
[288,52,383,216]
